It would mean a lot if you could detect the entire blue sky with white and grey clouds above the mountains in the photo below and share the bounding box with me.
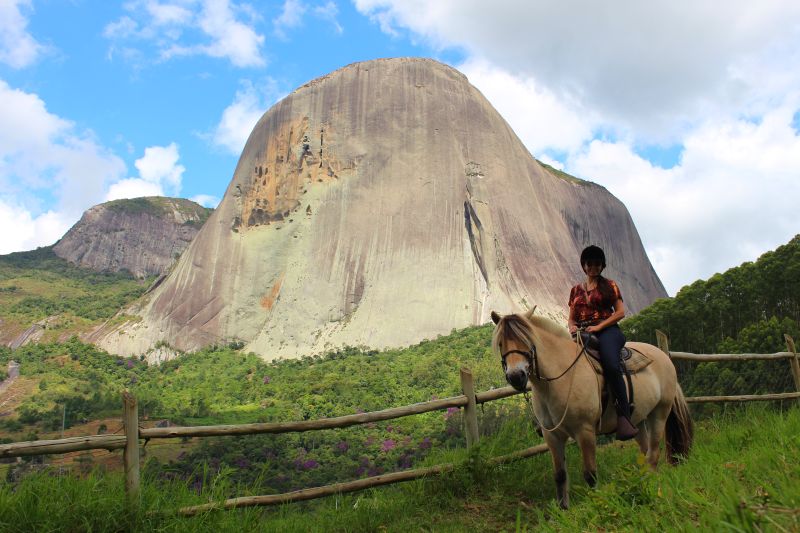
[0,0,800,295]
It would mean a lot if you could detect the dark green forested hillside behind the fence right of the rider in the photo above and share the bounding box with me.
[622,235,800,395]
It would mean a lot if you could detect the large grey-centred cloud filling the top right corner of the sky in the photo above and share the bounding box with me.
[355,0,800,141]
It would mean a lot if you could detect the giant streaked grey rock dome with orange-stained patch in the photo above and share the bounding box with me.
[95,58,666,359]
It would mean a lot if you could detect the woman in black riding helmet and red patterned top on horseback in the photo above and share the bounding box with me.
[568,246,639,440]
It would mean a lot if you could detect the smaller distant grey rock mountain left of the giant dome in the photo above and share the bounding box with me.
[53,197,212,278]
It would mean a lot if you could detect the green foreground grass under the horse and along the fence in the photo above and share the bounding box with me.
[0,405,800,532]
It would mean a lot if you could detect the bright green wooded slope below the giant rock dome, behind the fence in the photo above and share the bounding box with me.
[0,326,506,493]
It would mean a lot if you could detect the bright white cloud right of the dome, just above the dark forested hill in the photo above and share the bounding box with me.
[567,98,800,294]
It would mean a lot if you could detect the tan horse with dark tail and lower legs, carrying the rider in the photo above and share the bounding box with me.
[491,307,694,509]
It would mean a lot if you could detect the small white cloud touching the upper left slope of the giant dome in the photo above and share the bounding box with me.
[211,79,285,156]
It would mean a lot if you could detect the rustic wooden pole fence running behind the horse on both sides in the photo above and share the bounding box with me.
[0,331,800,515]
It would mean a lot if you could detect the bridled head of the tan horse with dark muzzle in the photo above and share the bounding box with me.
[491,308,536,391]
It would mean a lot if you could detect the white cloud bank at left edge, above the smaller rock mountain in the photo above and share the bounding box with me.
[0,80,198,254]
